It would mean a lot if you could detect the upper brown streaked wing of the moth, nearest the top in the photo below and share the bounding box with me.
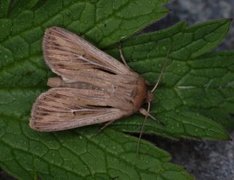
[43,27,130,81]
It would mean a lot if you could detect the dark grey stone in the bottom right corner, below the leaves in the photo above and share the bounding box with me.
[152,133,234,180]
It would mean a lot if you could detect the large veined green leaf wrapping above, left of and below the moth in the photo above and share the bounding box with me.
[0,0,192,179]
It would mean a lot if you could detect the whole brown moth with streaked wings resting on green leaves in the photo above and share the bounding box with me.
[29,27,157,132]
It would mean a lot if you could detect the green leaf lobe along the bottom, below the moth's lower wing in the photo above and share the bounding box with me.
[0,117,190,179]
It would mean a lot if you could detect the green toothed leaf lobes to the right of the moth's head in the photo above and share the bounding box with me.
[108,20,234,139]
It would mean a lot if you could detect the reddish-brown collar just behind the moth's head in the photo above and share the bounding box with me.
[134,77,147,111]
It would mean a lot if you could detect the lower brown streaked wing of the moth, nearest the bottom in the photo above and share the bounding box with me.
[30,88,127,132]
